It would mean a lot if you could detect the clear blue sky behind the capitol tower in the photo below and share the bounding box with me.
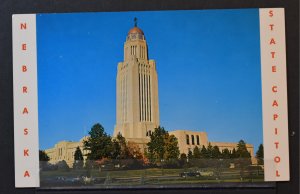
[37,9,262,152]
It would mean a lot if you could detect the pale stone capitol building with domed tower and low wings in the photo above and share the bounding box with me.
[45,20,256,167]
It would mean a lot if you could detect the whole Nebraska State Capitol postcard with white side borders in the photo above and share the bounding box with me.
[12,8,290,188]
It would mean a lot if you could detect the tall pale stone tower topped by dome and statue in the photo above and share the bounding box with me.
[114,18,159,143]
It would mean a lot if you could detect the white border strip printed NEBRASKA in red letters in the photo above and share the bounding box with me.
[12,14,40,187]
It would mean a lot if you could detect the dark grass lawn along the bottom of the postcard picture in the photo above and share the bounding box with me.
[41,168,264,187]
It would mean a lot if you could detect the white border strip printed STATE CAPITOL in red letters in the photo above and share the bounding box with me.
[259,8,290,181]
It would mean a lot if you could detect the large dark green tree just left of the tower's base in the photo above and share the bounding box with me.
[83,123,115,161]
